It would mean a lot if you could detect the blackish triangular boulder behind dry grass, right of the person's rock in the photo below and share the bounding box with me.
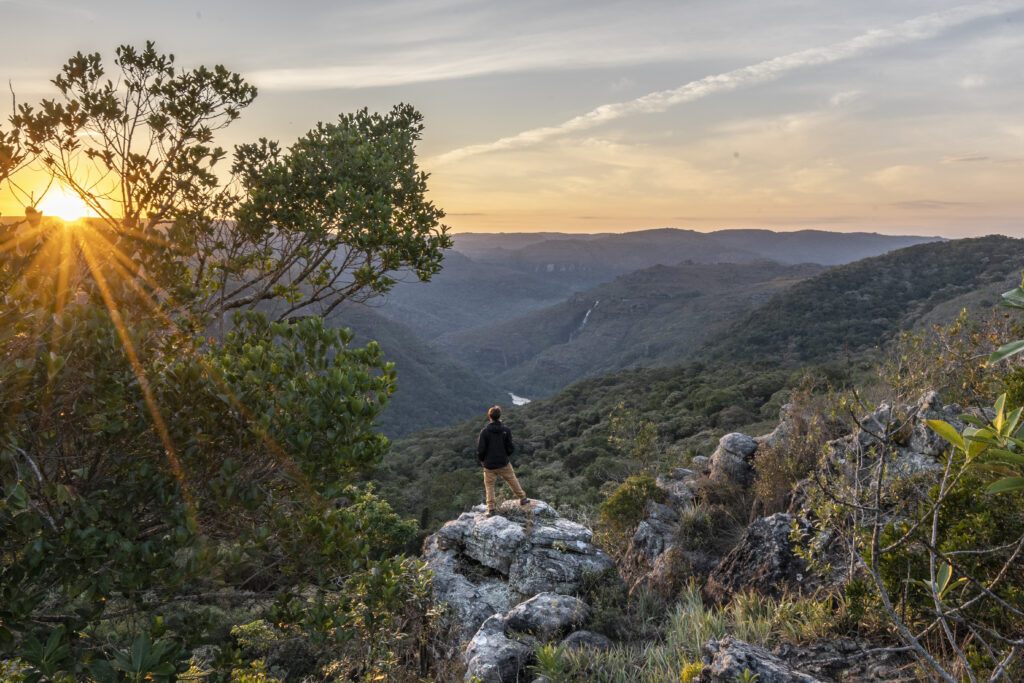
[705,512,821,601]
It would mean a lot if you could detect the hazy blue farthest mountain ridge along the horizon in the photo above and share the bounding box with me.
[378,228,940,340]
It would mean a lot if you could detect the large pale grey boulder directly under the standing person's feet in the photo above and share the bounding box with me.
[423,501,614,637]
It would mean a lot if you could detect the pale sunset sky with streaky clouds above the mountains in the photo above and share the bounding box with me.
[0,0,1024,238]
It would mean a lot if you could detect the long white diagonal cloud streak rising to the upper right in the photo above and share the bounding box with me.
[434,0,1022,164]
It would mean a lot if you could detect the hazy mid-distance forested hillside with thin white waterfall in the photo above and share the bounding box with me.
[436,261,823,398]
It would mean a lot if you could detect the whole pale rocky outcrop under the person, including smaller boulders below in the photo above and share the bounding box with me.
[423,501,614,683]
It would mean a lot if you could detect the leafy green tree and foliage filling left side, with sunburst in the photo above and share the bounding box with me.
[0,43,451,681]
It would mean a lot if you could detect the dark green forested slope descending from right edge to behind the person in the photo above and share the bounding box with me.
[374,237,1024,528]
